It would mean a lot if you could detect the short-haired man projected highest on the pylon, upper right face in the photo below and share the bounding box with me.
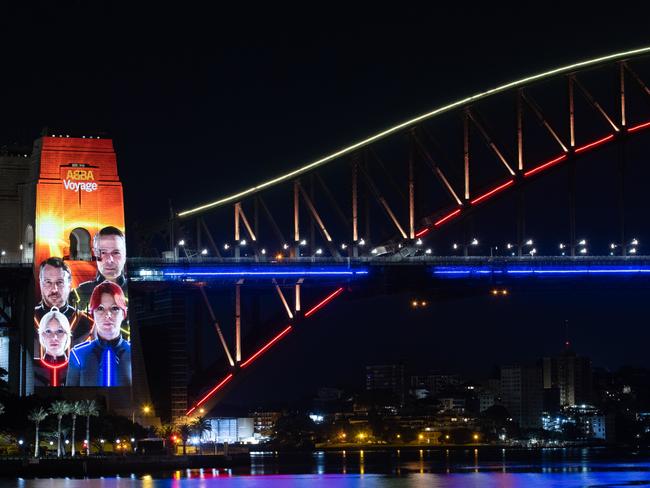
[73,226,126,310]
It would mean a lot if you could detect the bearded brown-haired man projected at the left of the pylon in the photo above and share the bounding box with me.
[34,257,93,346]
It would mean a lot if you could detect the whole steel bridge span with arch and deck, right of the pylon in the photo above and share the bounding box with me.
[3,44,650,416]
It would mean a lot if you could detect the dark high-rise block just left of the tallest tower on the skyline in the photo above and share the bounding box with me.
[501,364,543,428]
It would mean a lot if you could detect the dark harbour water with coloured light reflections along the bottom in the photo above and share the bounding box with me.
[10,448,650,488]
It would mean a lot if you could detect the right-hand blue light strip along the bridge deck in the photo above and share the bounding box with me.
[433,266,650,278]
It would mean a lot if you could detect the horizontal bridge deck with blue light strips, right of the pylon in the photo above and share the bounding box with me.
[128,254,650,287]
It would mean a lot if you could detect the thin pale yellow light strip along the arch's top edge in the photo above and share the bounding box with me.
[178,47,650,217]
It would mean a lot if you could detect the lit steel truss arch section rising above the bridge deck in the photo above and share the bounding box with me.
[177,47,650,258]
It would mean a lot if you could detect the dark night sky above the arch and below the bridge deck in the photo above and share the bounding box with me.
[0,2,650,402]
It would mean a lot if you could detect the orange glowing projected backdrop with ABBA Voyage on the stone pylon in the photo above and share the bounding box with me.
[34,137,124,287]
